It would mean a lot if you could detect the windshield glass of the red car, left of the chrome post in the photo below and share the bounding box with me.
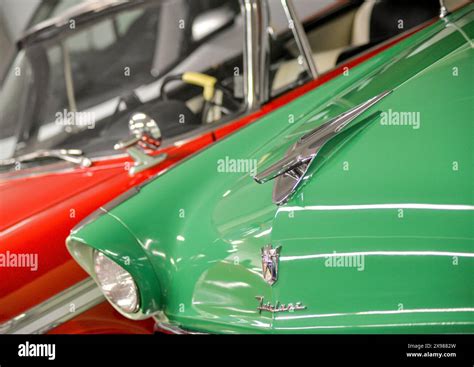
[0,0,243,158]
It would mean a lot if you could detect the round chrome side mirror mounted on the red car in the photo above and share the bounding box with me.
[114,113,167,175]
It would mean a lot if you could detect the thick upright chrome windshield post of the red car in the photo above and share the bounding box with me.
[240,0,270,110]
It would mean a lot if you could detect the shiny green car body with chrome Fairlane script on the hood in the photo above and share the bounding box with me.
[68,4,474,333]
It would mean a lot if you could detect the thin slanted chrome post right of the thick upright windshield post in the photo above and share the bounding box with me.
[281,0,318,79]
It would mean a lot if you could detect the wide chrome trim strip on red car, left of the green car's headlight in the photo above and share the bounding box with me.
[0,278,105,334]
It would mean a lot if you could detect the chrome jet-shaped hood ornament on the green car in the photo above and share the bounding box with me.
[254,90,392,205]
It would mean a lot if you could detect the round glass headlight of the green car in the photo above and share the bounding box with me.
[94,251,139,313]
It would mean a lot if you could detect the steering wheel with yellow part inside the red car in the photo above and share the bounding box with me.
[160,72,240,121]
